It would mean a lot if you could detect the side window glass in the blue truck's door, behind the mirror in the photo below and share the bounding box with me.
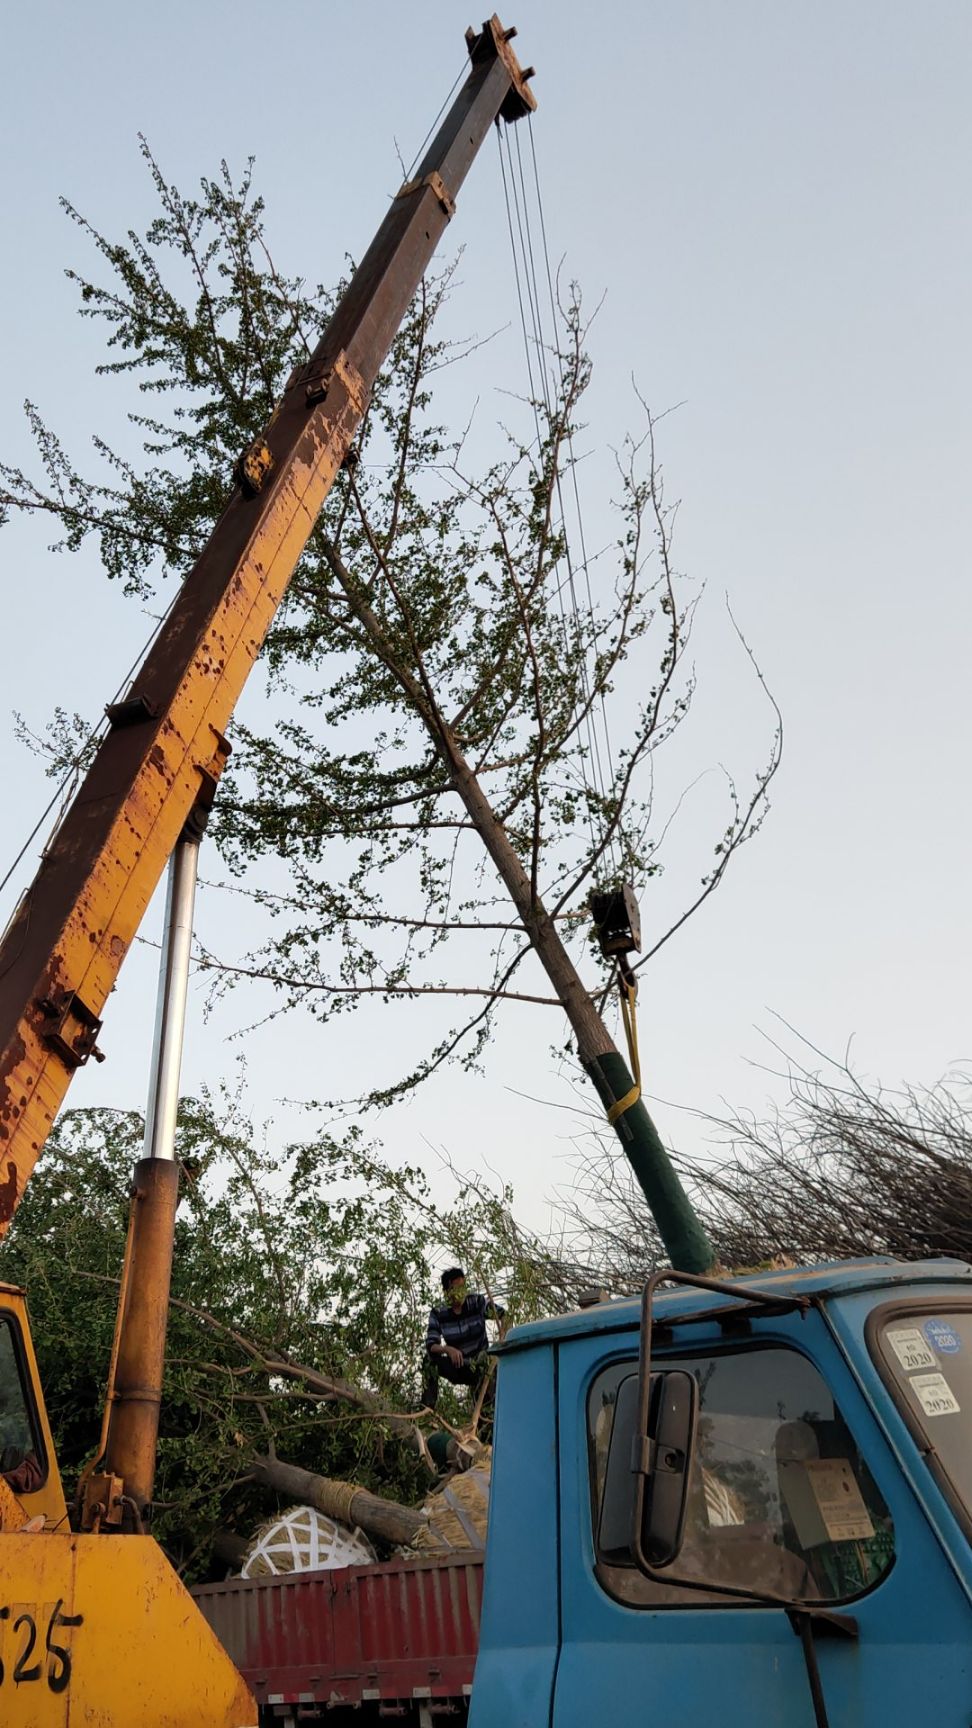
[588,1346,894,1607]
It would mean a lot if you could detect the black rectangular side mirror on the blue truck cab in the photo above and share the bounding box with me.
[597,1369,699,1569]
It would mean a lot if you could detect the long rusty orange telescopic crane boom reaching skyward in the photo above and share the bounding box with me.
[0,17,534,1236]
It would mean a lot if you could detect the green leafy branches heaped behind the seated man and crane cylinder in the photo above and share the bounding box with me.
[0,1097,560,1576]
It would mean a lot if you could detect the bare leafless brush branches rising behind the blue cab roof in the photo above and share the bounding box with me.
[560,1052,972,1291]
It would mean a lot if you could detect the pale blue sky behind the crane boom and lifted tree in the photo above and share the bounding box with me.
[0,0,972,1213]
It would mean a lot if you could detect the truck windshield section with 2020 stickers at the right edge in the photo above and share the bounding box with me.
[879,1308,972,1512]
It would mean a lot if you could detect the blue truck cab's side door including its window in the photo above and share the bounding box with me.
[553,1313,972,1728]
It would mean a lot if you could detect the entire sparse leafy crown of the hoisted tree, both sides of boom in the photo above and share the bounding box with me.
[0,147,780,1133]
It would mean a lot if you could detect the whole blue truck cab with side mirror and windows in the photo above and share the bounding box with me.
[469,1260,972,1728]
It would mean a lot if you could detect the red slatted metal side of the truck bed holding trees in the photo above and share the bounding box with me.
[192,1550,483,1728]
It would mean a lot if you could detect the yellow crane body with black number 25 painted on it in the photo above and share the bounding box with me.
[0,1284,256,1728]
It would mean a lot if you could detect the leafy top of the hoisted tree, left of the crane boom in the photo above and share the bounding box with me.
[0,150,330,596]
